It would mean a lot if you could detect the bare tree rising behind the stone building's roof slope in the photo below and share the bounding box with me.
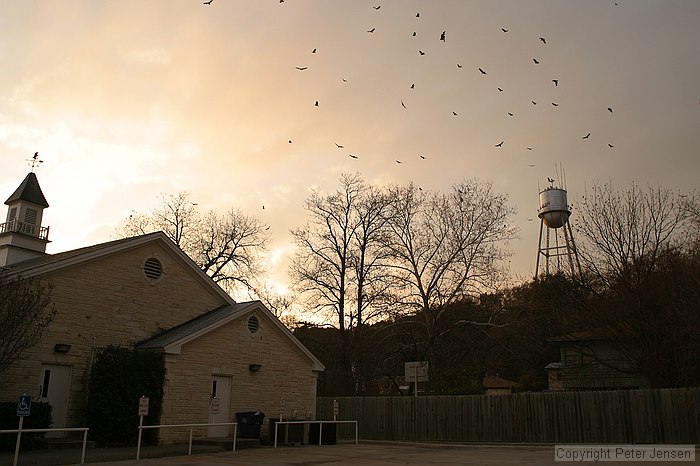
[116,192,268,292]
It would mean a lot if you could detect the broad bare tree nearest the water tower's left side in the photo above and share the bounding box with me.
[380,180,516,380]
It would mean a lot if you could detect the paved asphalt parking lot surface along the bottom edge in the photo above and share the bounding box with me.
[0,441,700,466]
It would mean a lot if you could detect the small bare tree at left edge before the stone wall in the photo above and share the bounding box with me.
[0,271,56,374]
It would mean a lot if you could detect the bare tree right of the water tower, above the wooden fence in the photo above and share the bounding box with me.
[577,185,700,387]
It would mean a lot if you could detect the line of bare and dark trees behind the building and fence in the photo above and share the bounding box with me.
[2,177,700,395]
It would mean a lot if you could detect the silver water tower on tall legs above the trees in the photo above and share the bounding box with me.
[535,178,581,278]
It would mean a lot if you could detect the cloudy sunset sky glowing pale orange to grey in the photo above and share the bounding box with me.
[0,0,700,294]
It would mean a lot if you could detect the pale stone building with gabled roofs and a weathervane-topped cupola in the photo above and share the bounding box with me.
[0,173,324,442]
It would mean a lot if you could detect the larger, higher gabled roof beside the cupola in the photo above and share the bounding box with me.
[6,231,235,304]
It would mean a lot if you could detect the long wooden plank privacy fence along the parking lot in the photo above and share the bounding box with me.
[317,387,700,444]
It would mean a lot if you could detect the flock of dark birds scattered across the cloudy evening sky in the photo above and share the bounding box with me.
[203,0,617,171]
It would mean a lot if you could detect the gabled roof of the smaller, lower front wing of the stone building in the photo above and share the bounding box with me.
[135,301,325,371]
